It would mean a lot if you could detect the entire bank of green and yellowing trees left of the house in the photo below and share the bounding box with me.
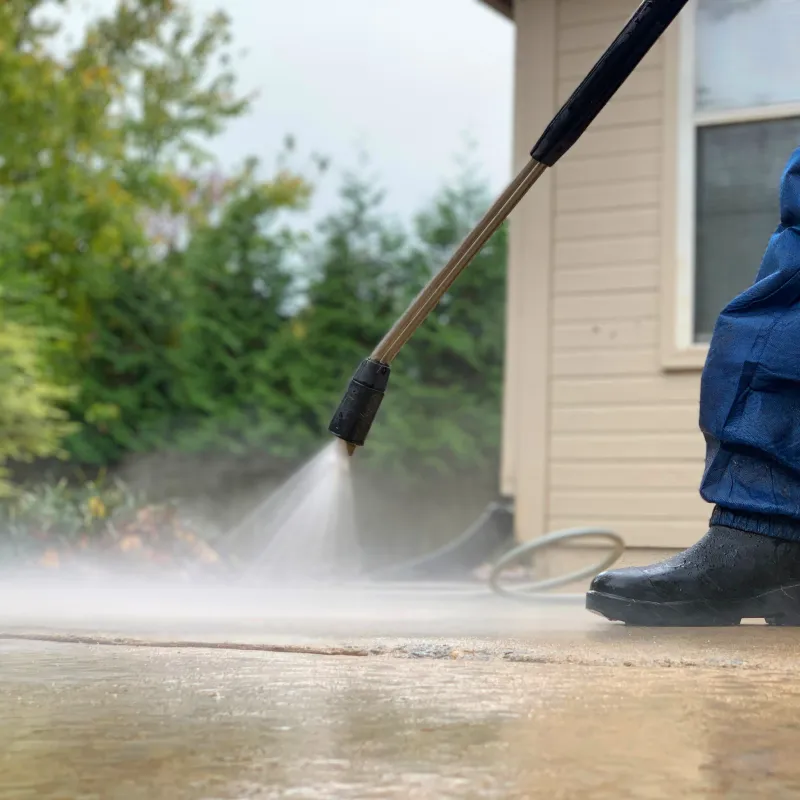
[0,0,506,494]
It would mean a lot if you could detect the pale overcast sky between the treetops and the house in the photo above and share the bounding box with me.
[184,0,514,216]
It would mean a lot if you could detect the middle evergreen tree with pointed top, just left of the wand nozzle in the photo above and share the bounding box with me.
[260,175,417,449]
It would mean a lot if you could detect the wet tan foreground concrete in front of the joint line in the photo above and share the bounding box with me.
[0,642,800,800]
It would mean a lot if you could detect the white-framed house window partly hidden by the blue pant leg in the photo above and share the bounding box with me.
[679,0,800,344]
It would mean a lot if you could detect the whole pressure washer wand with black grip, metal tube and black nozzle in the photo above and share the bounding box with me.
[328,0,688,455]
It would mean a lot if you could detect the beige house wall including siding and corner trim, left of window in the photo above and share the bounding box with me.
[502,0,709,548]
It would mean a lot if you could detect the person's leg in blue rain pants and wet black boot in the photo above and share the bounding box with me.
[587,149,800,625]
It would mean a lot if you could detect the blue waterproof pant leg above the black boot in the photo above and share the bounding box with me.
[700,148,800,541]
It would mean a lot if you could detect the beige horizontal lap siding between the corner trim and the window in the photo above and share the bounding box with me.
[546,0,709,548]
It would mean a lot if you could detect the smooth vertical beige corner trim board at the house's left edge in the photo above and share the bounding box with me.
[500,0,557,539]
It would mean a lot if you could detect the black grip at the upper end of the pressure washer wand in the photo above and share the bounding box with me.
[531,0,688,167]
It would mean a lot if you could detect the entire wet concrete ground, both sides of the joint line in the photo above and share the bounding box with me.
[0,587,800,800]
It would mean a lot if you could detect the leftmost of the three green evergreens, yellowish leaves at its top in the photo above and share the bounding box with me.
[173,167,308,452]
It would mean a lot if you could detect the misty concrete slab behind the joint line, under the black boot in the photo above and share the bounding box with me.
[0,584,800,671]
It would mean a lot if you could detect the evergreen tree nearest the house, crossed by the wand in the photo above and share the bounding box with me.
[362,168,507,473]
